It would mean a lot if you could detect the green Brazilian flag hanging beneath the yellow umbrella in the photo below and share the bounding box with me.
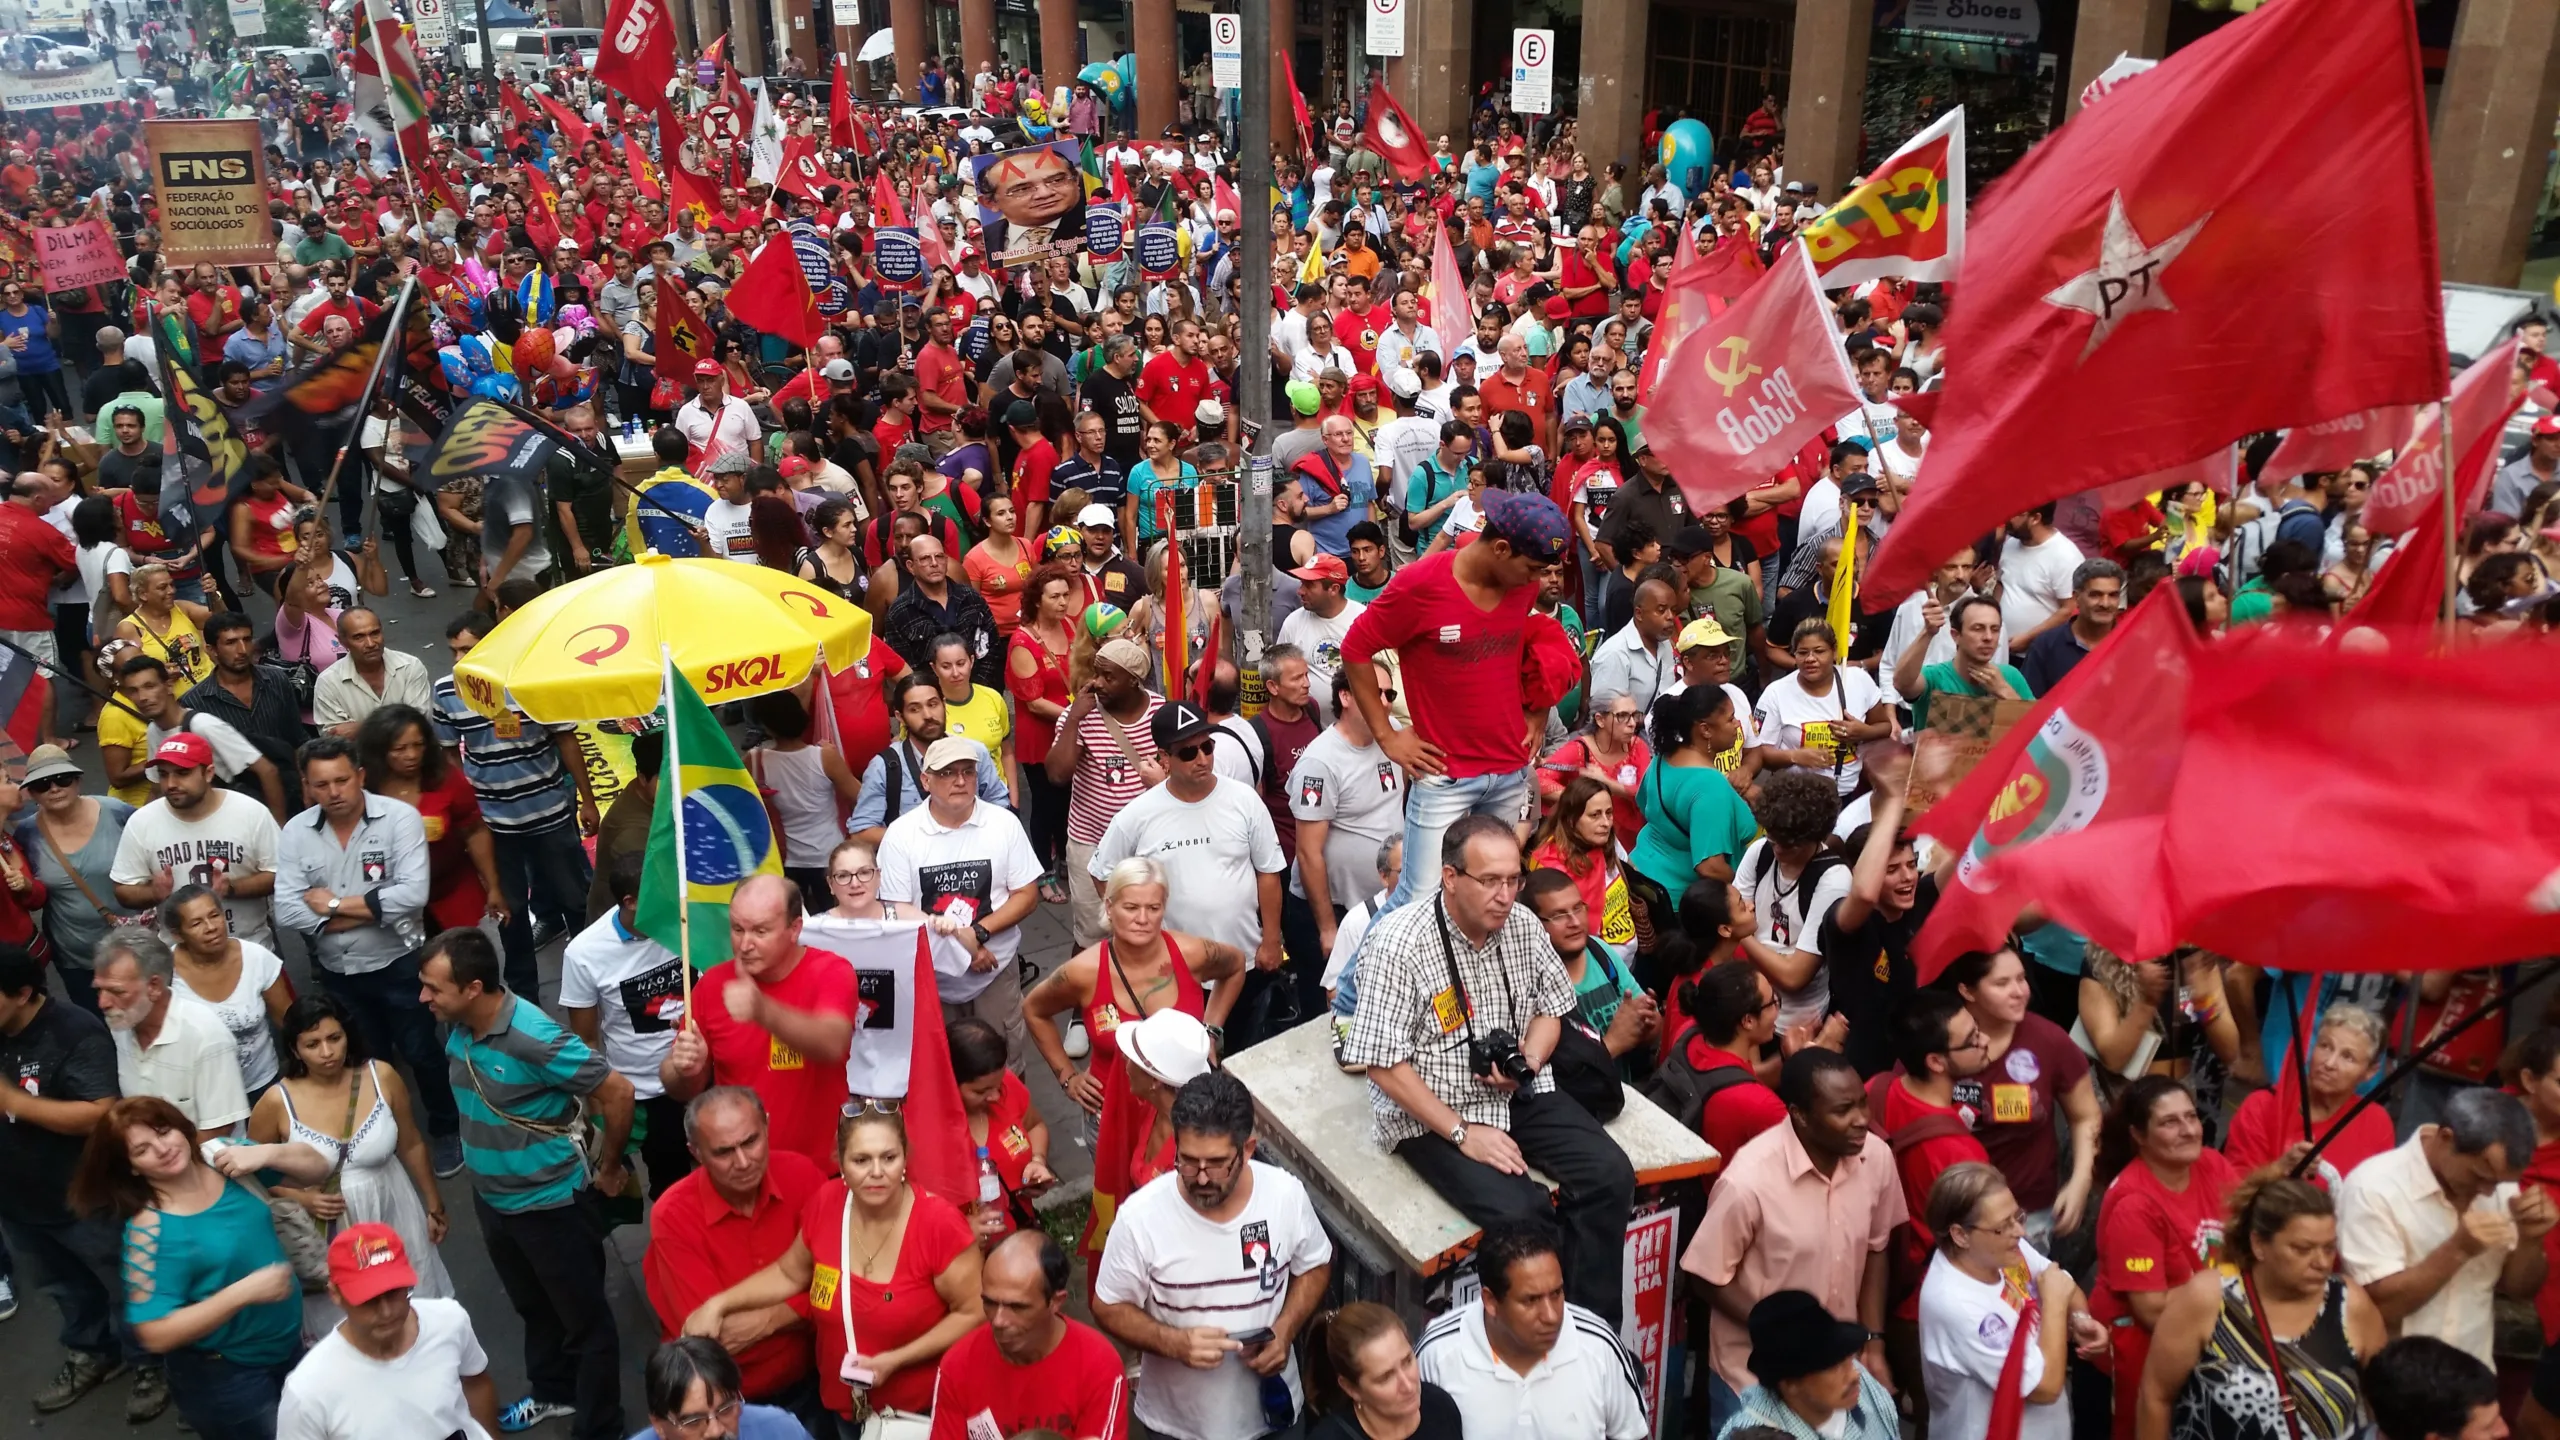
[637,664,783,971]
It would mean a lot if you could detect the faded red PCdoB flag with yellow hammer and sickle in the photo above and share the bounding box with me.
[1644,246,1863,517]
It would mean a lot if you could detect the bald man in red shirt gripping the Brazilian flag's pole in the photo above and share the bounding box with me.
[658,874,855,1176]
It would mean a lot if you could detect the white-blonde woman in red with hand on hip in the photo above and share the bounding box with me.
[1021,856,1244,1291]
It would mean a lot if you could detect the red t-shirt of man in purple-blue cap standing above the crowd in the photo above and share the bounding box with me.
[1341,551,1539,779]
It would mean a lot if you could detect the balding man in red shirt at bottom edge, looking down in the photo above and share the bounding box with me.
[932,1230,1129,1440]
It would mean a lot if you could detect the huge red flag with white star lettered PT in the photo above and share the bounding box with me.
[1871,0,2445,602]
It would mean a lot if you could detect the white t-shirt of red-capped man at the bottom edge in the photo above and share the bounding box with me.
[276,1299,489,1440]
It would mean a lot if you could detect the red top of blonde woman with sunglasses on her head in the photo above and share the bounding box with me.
[801,1178,983,1414]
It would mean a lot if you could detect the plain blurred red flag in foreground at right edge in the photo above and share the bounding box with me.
[2160,632,2560,971]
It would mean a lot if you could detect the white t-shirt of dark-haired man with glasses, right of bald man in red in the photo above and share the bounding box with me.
[1093,1161,1334,1440]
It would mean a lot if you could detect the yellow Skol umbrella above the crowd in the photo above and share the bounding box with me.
[453,551,870,725]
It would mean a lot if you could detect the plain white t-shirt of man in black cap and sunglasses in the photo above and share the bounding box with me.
[1085,776,1288,953]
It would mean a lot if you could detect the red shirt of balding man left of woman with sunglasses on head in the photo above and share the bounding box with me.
[640,1150,827,1394]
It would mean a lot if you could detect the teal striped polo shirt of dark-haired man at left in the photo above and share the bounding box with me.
[445,994,612,1215]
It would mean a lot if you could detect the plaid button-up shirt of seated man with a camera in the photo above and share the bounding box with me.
[1341,897,1574,1148]
